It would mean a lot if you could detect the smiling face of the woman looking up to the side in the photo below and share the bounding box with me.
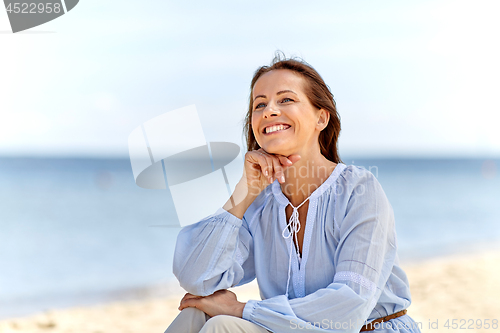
[252,69,329,156]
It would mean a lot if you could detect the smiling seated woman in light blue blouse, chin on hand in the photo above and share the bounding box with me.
[167,56,420,333]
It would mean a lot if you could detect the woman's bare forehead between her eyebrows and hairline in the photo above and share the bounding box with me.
[253,69,303,97]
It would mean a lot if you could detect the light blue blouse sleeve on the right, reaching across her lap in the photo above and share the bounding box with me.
[243,168,396,333]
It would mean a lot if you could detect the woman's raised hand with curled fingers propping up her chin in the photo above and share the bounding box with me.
[243,148,300,195]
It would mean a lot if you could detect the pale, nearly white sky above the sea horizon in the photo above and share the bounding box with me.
[0,0,500,158]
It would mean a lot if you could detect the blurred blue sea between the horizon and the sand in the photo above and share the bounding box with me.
[0,157,500,319]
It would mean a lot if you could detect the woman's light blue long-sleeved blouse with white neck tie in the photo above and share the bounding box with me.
[173,163,421,332]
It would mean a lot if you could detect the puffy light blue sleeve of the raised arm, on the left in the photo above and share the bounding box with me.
[173,208,255,296]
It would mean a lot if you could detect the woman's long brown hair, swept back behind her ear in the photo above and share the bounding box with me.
[244,53,342,163]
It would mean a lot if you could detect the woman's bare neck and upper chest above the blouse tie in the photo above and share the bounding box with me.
[280,152,337,207]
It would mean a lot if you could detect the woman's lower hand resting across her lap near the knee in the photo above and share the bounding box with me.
[179,290,246,318]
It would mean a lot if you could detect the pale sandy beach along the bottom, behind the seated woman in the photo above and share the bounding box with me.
[0,251,500,333]
